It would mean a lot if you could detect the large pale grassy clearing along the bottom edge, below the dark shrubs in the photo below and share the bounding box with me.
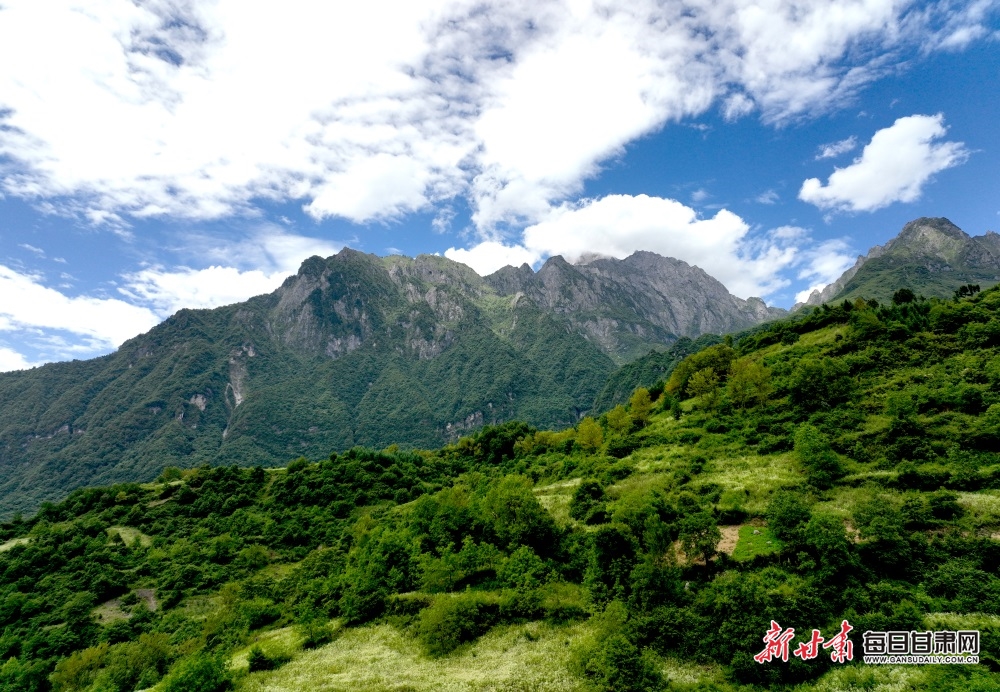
[237,622,587,692]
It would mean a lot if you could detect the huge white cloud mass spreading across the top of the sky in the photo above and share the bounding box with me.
[0,0,992,232]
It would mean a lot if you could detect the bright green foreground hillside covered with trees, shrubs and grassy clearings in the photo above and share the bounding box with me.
[0,287,1000,692]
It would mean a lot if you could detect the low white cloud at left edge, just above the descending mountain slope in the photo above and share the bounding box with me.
[0,265,159,349]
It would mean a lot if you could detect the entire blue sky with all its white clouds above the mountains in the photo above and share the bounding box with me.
[0,0,1000,370]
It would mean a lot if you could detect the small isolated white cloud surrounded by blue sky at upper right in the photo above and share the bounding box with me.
[799,113,969,211]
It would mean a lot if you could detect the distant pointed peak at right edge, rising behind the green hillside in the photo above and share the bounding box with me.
[805,217,1000,305]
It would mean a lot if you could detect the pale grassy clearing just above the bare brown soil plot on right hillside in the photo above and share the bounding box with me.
[697,454,803,514]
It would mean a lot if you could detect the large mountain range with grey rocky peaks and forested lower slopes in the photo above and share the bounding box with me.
[0,249,773,516]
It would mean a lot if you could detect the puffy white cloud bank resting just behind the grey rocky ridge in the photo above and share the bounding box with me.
[445,195,808,297]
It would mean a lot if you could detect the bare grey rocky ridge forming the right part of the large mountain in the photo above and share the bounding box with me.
[486,252,786,362]
